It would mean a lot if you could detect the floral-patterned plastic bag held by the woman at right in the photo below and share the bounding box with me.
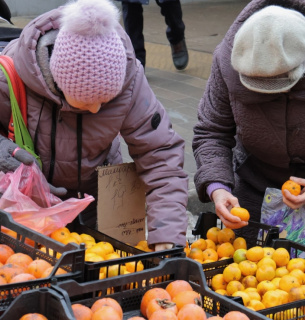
[261,188,305,245]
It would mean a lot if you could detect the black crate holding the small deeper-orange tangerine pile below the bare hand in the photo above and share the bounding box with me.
[192,212,279,272]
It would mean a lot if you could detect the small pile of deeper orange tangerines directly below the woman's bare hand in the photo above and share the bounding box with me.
[184,227,247,263]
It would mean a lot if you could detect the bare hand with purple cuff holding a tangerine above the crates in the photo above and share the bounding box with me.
[211,189,247,229]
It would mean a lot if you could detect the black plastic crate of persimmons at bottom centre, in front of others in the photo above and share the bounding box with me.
[52,258,267,320]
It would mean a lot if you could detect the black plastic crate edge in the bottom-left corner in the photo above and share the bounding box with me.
[0,288,75,320]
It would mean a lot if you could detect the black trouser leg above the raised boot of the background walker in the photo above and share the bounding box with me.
[156,0,185,44]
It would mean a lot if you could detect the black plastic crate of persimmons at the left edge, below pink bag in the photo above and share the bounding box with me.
[0,210,85,315]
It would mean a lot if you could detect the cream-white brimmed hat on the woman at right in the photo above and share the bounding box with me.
[231,6,305,93]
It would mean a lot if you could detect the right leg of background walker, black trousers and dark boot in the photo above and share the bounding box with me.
[156,0,188,70]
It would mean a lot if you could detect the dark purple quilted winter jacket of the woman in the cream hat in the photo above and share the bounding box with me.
[193,0,305,220]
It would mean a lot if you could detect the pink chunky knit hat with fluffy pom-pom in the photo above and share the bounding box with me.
[50,0,127,103]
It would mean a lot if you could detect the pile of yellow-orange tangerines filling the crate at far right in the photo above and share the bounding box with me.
[210,246,305,311]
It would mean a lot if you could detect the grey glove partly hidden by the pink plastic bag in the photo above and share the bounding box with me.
[0,135,67,197]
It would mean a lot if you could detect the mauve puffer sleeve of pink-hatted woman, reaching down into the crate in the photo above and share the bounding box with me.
[121,64,188,246]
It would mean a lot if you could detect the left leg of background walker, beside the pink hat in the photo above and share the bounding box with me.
[122,1,146,68]
